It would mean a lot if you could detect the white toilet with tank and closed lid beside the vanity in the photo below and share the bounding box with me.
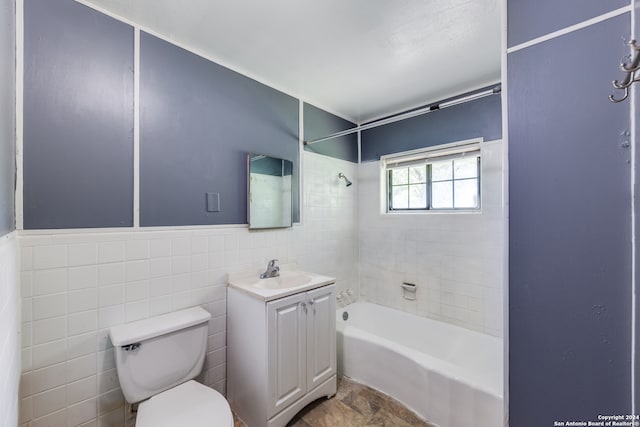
[109,307,233,427]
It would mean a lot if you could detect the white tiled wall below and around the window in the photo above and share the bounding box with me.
[359,141,504,337]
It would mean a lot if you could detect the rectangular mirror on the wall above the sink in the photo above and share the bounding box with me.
[247,153,293,230]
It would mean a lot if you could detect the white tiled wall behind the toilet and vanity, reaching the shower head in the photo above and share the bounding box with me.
[20,152,358,427]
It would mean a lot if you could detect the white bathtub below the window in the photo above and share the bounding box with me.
[336,303,504,427]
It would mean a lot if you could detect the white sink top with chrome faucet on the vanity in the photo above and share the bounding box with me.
[229,269,335,301]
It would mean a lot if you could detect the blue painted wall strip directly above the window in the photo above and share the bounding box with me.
[361,89,502,162]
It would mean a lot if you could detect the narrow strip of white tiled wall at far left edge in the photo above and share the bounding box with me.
[0,232,20,427]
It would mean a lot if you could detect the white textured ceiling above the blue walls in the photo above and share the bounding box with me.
[83,0,501,123]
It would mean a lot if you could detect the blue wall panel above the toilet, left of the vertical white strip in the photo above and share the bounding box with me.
[24,0,133,229]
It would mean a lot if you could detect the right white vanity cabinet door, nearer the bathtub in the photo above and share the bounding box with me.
[307,285,336,390]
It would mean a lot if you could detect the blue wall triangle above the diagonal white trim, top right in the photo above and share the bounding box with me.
[507,0,629,47]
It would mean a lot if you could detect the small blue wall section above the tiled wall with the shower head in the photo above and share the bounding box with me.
[304,102,358,163]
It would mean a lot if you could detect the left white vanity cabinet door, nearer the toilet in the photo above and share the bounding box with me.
[264,293,307,418]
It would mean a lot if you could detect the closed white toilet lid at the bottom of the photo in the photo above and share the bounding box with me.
[136,380,233,427]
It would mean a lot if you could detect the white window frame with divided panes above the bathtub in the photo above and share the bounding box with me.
[380,138,483,214]
